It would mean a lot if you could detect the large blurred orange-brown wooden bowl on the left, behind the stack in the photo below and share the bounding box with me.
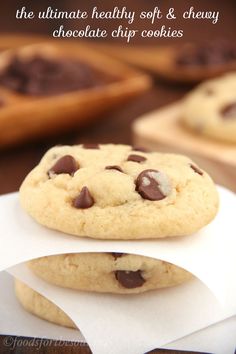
[0,42,151,147]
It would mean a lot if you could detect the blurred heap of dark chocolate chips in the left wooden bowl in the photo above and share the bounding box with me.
[0,55,108,96]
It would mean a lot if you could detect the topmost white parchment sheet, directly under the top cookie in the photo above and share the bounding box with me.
[0,187,236,303]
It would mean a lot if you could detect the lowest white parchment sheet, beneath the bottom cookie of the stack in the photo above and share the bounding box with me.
[0,272,236,354]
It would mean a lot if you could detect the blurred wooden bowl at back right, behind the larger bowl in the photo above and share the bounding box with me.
[85,42,236,84]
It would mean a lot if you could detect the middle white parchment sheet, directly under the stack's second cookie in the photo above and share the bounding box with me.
[8,264,236,354]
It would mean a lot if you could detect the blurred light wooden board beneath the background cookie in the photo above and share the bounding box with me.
[133,102,236,191]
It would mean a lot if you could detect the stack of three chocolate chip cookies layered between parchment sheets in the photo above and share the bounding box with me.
[16,144,218,327]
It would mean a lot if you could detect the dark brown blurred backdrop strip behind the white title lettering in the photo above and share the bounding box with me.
[0,0,236,44]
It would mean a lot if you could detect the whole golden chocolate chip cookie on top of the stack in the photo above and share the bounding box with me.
[20,144,218,239]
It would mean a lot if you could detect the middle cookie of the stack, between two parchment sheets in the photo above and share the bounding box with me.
[28,253,192,294]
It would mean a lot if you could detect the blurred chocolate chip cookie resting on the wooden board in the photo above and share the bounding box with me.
[181,72,236,144]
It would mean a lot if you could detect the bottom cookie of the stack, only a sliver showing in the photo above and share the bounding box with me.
[15,279,77,328]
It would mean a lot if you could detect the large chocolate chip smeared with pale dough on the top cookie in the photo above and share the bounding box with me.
[136,170,171,201]
